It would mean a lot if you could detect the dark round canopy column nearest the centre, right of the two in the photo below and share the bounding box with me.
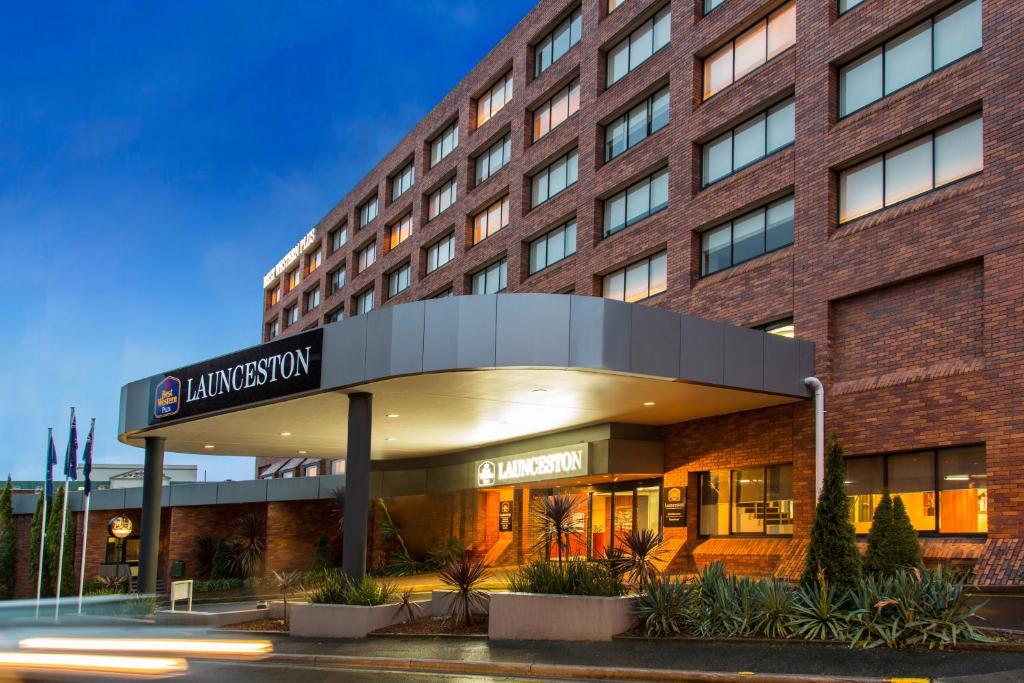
[342,393,374,581]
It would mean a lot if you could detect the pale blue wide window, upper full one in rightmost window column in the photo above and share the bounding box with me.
[839,0,981,117]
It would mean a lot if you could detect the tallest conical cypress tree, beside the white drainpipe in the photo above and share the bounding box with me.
[801,432,860,591]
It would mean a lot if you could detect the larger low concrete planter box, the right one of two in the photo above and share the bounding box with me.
[487,593,634,640]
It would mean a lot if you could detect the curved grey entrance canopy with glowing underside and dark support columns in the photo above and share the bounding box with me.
[119,294,813,588]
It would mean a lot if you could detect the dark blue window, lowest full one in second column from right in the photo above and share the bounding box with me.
[700,192,794,276]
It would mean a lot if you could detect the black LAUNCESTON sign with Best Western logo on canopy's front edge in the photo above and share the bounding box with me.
[150,328,324,424]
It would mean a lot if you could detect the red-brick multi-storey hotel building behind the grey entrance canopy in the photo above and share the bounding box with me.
[99,0,1024,584]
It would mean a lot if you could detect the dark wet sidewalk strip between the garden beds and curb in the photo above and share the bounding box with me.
[258,637,1024,681]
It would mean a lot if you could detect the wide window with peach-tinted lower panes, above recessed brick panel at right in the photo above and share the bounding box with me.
[839,114,983,223]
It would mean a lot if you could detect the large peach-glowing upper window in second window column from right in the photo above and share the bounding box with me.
[703,2,797,99]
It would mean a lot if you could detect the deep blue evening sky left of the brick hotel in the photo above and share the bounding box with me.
[0,0,534,480]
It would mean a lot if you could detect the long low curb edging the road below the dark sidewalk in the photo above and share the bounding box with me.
[263,653,888,683]
